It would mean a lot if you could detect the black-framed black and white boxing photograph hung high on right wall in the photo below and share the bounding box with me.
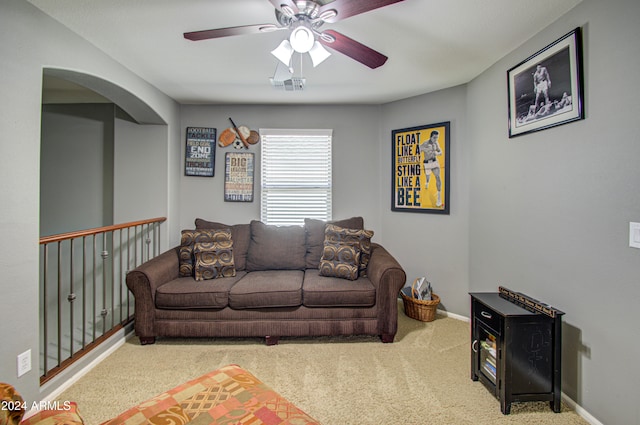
[507,28,584,137]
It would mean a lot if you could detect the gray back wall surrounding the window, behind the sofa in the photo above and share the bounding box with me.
[180,105,381,235]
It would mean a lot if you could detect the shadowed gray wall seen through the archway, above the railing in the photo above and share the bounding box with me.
[40,104,115,236]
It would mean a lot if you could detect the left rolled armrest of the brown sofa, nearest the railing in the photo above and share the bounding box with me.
[126,247,180,344]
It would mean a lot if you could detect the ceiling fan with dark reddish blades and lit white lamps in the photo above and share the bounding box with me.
[184,0,403,69]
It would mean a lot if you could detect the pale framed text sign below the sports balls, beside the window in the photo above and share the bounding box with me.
[224,152,255,202]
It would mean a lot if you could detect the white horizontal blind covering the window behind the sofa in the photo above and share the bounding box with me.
[260,129,333,225]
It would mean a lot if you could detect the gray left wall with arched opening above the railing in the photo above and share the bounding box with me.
[0,0,179,403]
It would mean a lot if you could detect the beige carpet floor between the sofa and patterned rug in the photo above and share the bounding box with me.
[59,303,587,425]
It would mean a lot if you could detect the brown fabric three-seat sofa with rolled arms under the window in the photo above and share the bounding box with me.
[126,217,406,344]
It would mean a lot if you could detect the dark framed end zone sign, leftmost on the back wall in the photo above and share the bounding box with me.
[184,127,217,177]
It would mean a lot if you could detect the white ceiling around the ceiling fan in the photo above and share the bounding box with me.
[28,0,581,104]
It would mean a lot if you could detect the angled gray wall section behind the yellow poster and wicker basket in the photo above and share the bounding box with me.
[379,86,472,316]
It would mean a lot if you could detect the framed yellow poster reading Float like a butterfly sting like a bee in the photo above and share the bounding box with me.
[391,121,451,214]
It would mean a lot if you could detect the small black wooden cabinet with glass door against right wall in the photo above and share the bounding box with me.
[469,292,564,415]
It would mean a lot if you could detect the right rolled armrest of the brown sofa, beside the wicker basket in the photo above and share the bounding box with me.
[367,243,407,342]
